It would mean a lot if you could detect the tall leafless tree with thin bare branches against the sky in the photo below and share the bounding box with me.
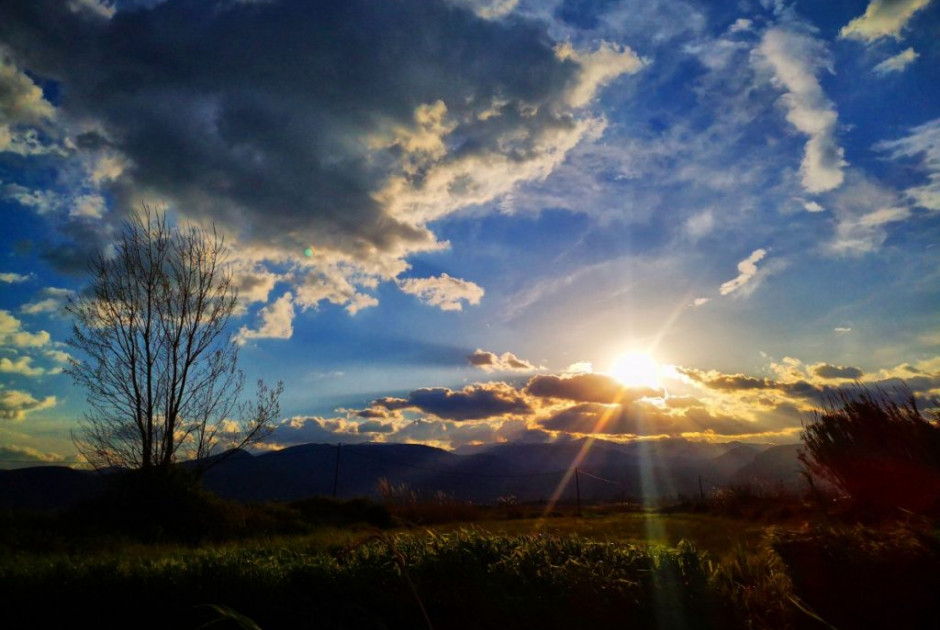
[66,206,283,473]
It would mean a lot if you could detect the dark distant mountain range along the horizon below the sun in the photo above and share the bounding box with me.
[0,440,799,509]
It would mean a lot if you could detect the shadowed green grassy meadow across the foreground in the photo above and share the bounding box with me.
[0,493,940,629]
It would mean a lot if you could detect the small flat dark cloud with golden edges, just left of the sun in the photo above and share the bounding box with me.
[372,383,532,420]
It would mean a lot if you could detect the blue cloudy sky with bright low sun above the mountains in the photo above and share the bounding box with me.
[0,0,940,467]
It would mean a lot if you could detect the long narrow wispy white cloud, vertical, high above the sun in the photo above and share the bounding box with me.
[755,28,846,193]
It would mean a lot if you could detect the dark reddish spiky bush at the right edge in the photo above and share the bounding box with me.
[800,386,940,514]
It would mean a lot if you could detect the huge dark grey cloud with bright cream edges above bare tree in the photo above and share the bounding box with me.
[0,0,642,312]
